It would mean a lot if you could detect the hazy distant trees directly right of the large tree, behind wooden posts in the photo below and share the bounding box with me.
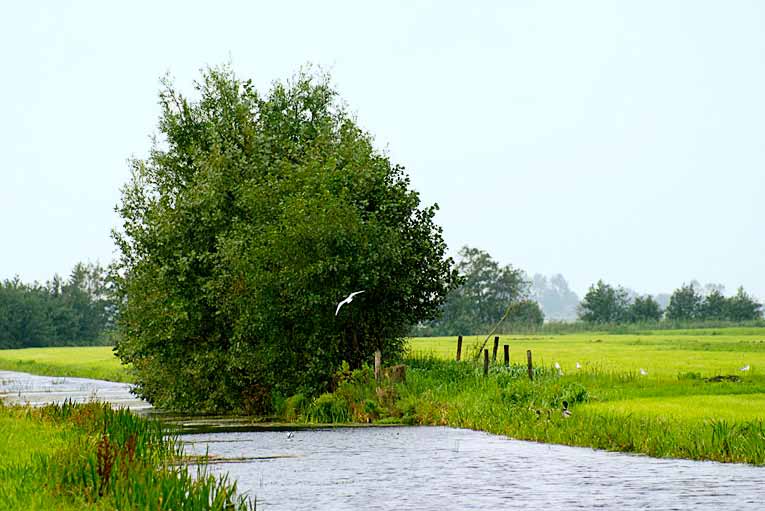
[414,246,544,335]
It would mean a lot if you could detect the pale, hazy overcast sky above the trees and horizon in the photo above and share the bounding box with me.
[0,0,765,298]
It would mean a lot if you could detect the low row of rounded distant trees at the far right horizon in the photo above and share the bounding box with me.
[579,280,762,324]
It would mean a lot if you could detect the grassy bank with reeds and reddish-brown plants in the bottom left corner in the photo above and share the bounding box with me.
[0,403,254,511]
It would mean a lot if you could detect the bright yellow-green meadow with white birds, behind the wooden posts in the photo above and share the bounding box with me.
[410,328,765,428]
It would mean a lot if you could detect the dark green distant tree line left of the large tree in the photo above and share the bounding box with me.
[0,263,115,349]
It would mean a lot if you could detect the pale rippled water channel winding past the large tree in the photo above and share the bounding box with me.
[0,371,765,510]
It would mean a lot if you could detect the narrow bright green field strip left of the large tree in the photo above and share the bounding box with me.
[0,346,130,382]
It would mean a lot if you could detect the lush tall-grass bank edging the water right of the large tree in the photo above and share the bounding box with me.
[281,358,765,465]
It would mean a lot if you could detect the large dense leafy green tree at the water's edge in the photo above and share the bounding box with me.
[115,68,457,412]
